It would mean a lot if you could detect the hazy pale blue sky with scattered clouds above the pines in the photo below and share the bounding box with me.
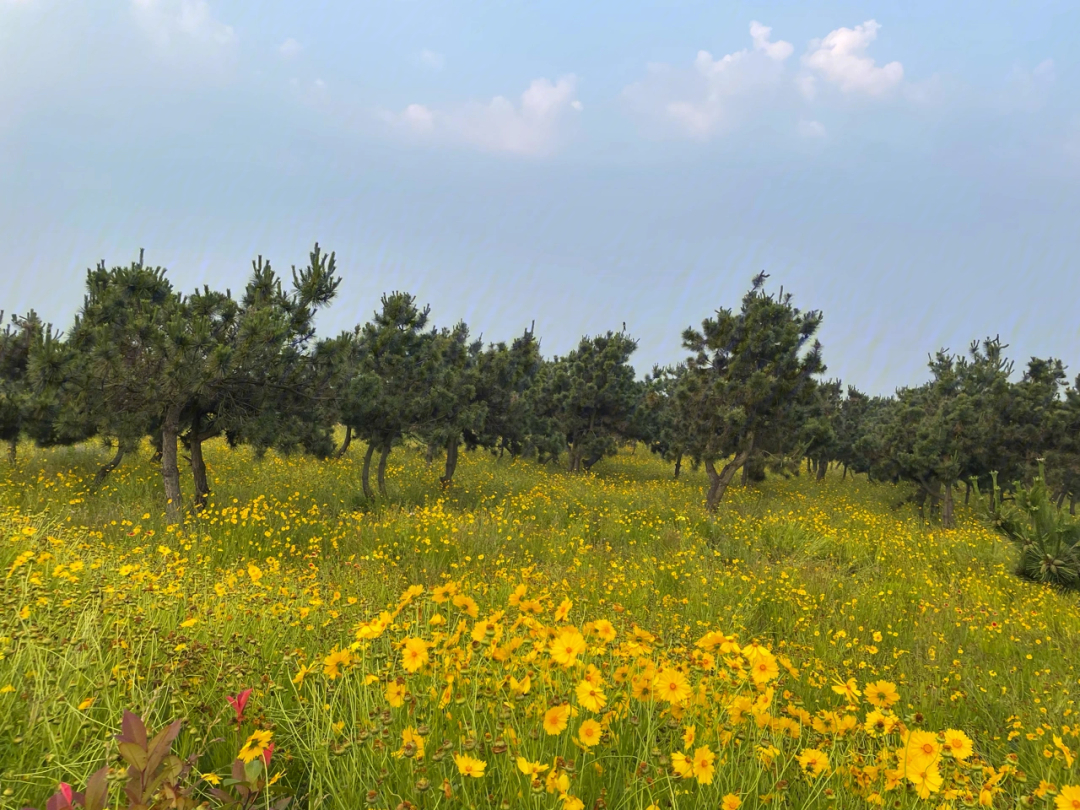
[0,0,1080,393]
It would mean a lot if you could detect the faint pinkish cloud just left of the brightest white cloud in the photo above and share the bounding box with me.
[623,21,794,139]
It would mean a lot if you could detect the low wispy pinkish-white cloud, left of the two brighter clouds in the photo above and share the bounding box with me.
[378,75,582,156]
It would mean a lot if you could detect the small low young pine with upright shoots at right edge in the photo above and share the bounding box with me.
[973,459,1080,590]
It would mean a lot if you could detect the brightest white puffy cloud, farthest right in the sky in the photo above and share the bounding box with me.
[799,19,904,98]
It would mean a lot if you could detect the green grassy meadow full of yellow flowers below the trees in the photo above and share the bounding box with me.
[0,442,1080,810]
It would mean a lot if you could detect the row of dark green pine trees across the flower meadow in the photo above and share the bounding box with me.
[0,244,1080,526]
